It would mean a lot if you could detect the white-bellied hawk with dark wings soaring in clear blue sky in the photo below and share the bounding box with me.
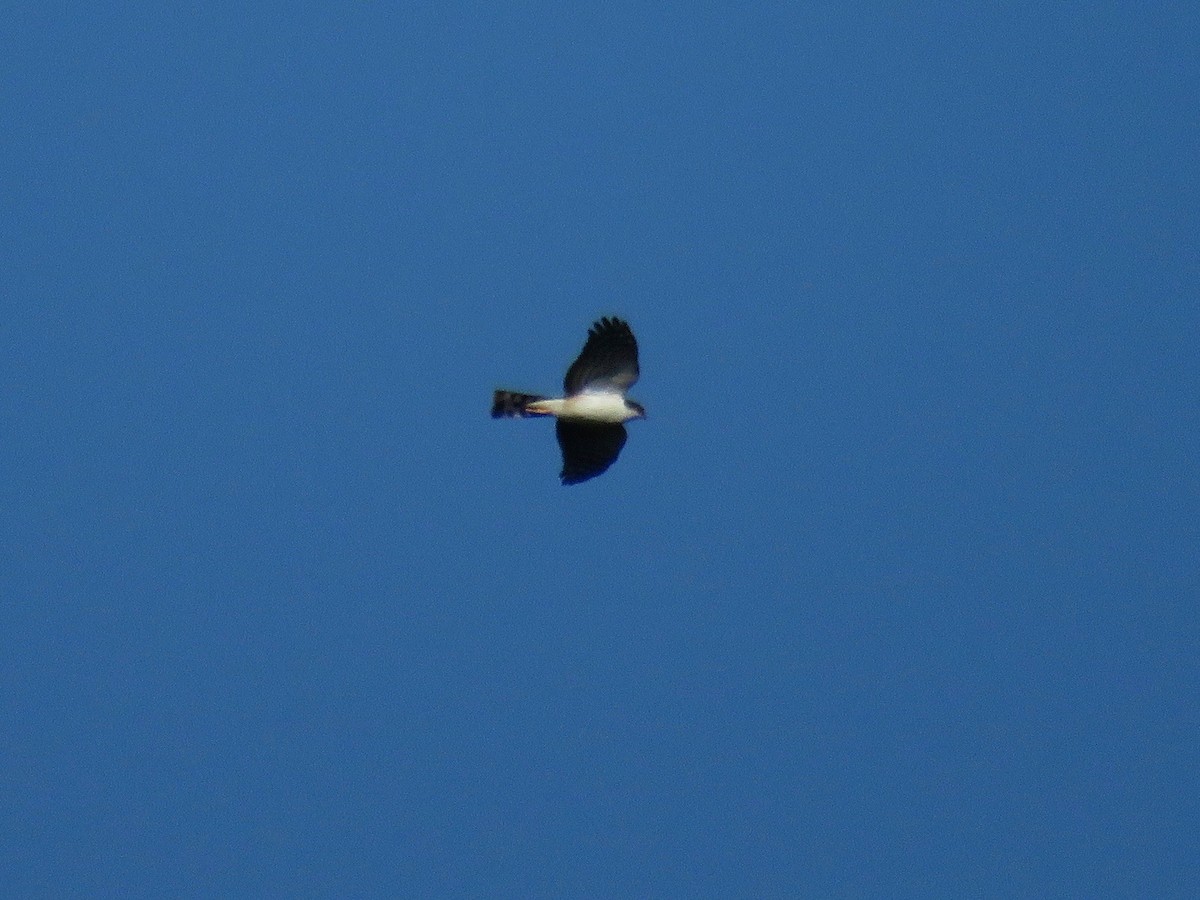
[492,318,646,485]
